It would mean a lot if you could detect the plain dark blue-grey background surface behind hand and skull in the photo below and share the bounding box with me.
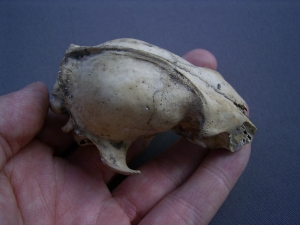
[0,1,300,224]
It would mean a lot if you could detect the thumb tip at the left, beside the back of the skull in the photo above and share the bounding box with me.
[0,82,49,168]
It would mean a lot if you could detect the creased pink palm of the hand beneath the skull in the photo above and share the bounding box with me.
[4,140,129,224]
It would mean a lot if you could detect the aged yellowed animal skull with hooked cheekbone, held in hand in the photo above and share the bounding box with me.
[50,39,256,174]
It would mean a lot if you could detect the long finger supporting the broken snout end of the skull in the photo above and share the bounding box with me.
[139,145,250,224]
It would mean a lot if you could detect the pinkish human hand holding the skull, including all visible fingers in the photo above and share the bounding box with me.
[0,49,251,225]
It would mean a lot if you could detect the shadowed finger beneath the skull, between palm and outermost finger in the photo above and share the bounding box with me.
[112,138,207,224]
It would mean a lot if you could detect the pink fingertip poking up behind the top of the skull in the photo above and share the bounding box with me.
[183,49,217,70]
